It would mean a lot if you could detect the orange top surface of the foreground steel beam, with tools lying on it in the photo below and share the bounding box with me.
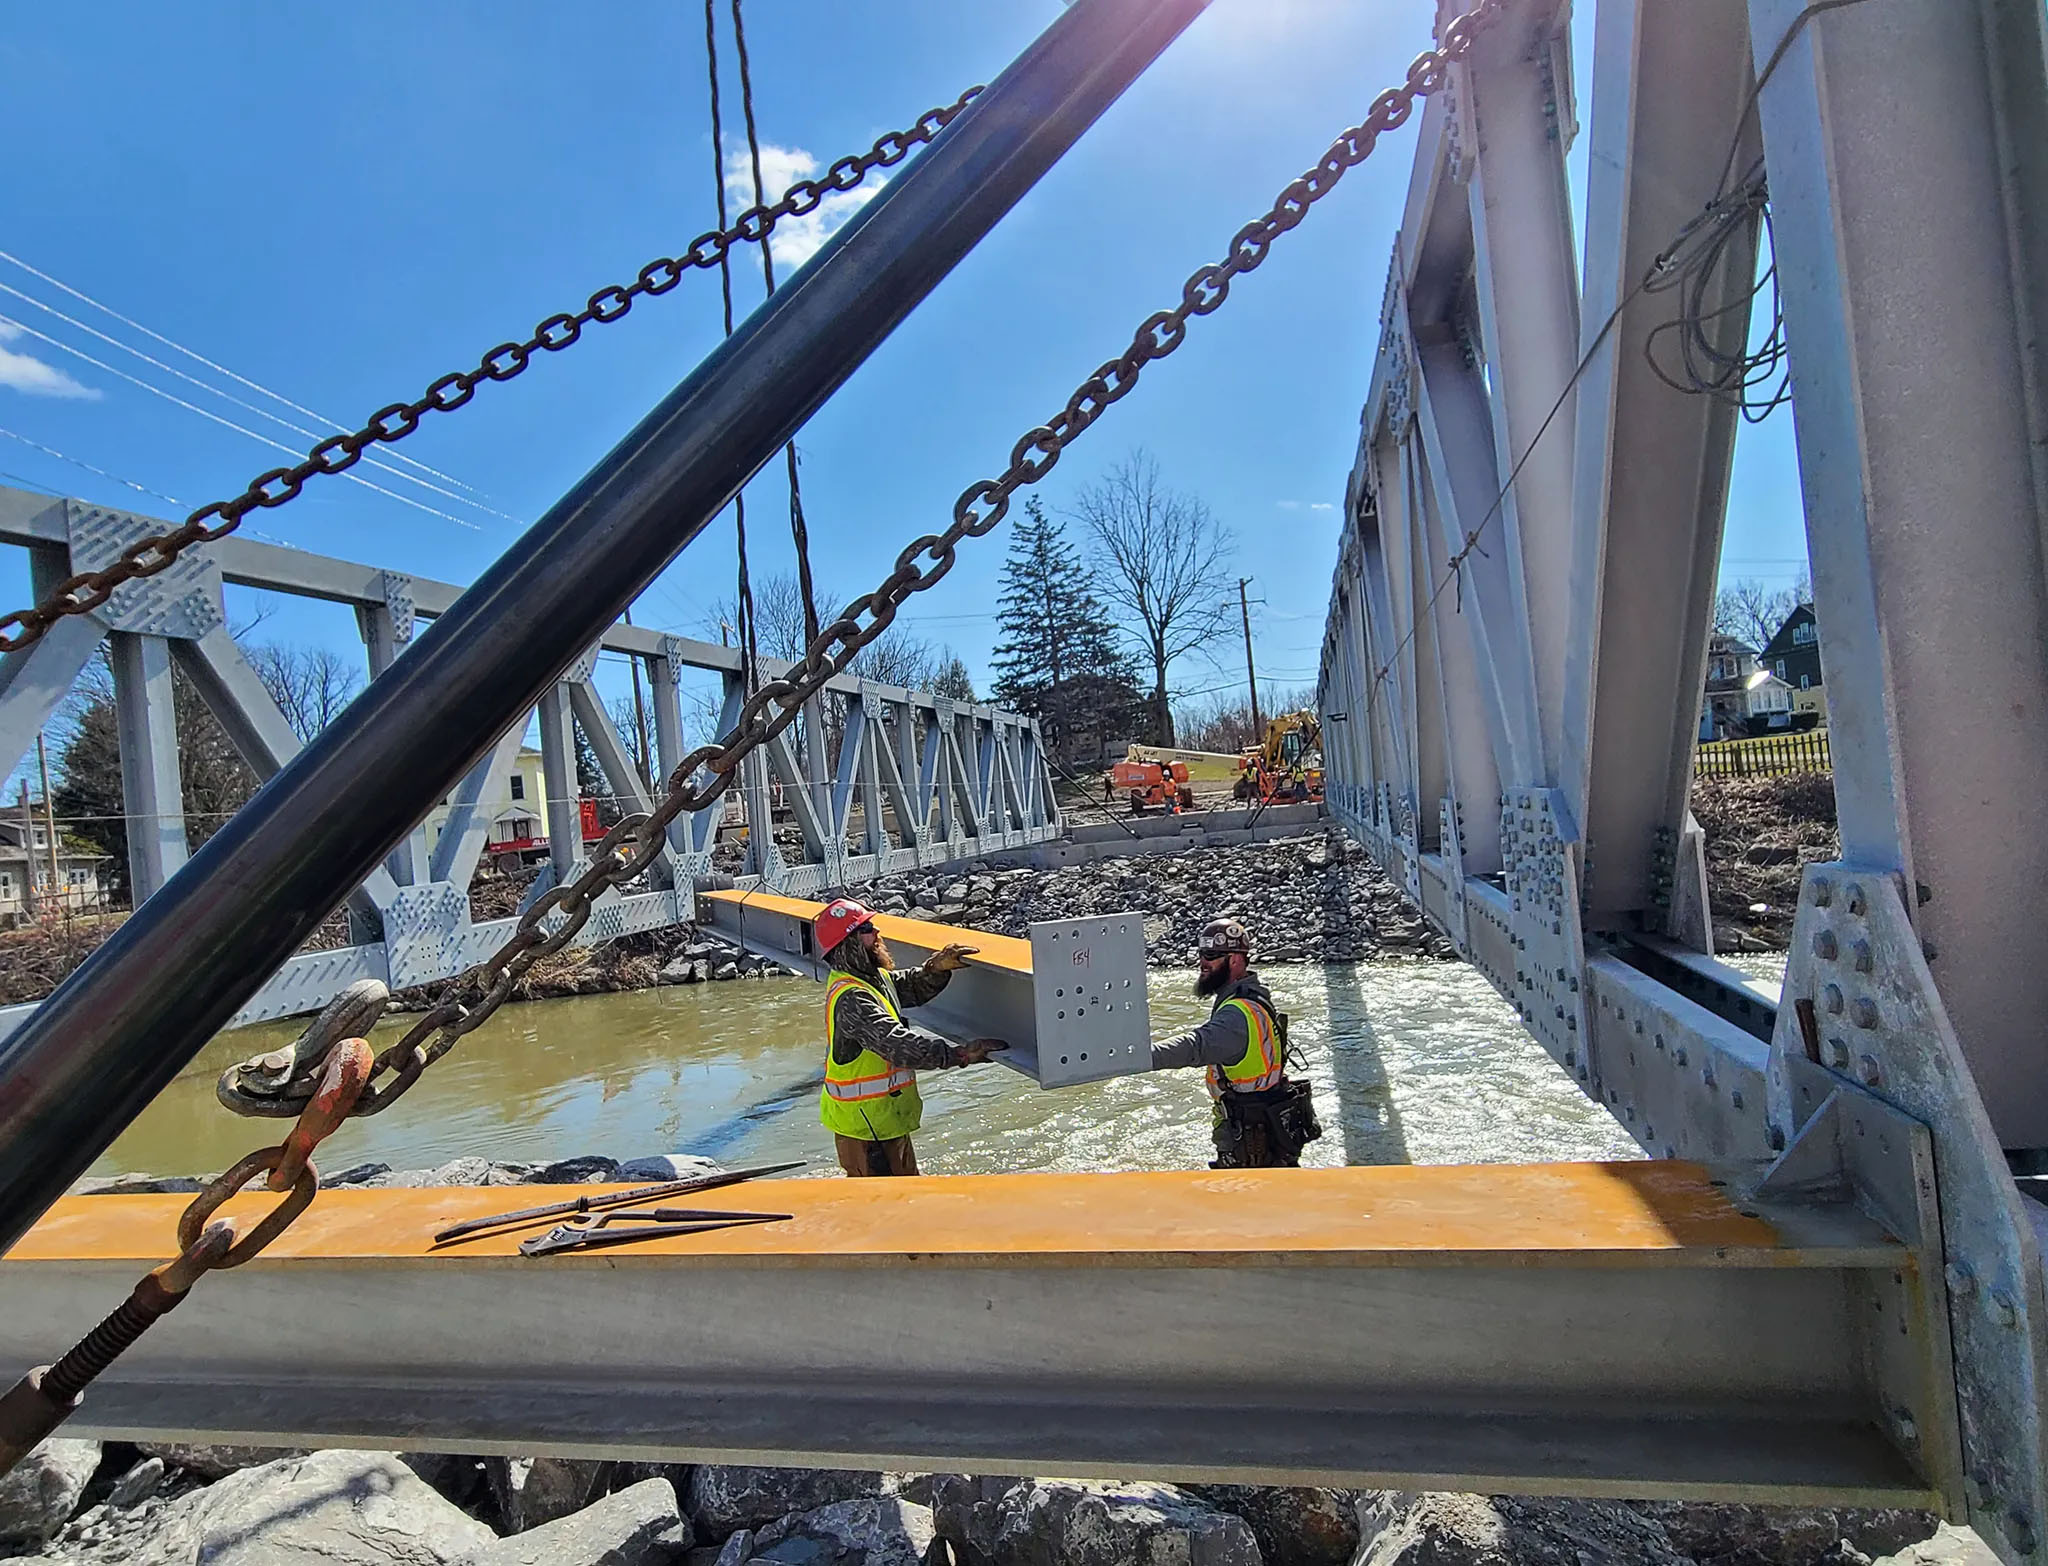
[12,1163,1810,1269]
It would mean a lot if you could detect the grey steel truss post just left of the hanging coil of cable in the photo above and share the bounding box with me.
[1561,0,1759,933]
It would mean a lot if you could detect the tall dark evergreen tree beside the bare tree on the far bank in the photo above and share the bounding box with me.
[989,495,1139,762]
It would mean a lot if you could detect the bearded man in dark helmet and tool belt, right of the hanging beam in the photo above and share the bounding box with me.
[1151,919,1323,1169]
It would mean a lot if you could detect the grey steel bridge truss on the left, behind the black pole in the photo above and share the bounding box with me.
[0,487,1061,1036]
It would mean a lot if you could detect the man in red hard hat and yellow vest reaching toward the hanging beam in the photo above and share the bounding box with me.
[813,897,1010,1177]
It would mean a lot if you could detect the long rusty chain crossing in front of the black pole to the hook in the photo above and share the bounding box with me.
[243,0,1507,1116]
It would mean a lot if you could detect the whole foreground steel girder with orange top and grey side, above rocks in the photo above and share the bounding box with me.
[0,1163,1939,1505]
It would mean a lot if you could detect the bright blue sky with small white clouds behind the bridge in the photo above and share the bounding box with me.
[0,0,1804,741]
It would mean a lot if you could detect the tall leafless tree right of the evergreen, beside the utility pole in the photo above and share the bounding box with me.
[1071,450,1231,745]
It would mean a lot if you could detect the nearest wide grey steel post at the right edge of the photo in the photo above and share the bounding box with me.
[1749,0,2048,1146]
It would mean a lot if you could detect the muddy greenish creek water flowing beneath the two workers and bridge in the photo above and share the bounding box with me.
[92,945,1776,1175]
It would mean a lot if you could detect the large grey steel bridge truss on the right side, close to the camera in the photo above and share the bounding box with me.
[1319,0,2048,1562]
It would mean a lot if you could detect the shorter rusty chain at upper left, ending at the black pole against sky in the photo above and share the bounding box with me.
[0,86,981,653]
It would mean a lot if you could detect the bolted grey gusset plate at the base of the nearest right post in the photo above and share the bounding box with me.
[1769,864,2048,1562]
